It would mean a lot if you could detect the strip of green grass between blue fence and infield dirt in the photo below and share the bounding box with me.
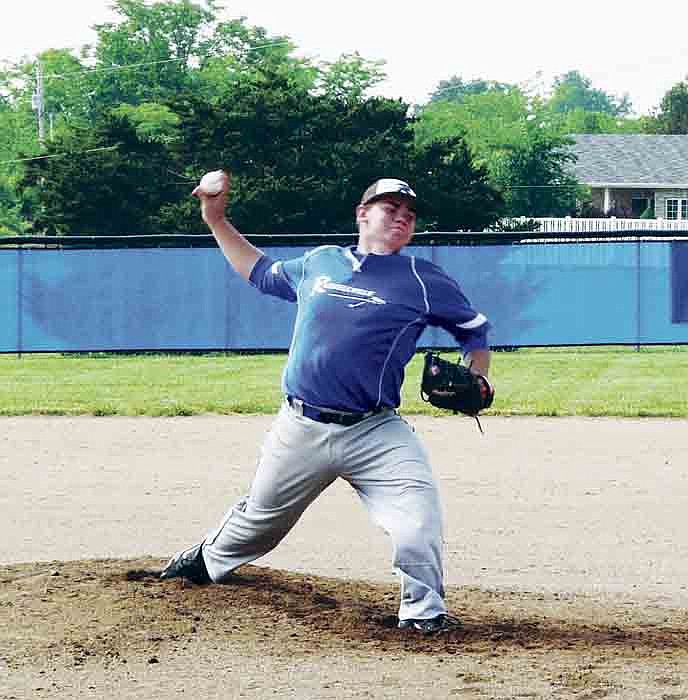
[0,346,688,418]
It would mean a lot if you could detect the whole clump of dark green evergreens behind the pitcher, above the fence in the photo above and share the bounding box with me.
[25,74,501,235]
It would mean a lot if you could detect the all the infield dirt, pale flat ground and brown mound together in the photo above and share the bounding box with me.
[0,416,688,700]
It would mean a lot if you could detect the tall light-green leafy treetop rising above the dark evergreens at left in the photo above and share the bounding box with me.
[93,0,318,110]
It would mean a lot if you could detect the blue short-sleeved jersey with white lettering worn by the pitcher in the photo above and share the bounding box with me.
[250,245,489,413]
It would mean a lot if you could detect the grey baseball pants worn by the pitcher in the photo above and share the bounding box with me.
[203,403,447,620]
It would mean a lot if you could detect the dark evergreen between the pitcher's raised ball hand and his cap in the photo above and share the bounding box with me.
[167,73,412,233]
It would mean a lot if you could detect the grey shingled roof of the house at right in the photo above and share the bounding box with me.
[569,134,688,188]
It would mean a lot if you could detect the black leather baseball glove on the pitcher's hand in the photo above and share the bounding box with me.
[420,352,494,418]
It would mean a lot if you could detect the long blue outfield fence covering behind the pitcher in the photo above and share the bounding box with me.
[0,239,688,353]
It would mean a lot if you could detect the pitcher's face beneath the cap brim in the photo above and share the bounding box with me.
[356,195,416,254]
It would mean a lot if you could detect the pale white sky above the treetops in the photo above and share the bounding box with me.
[0,0,688,114]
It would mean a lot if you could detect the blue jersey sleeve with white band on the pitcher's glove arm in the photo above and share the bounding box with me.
[422,265,490,352]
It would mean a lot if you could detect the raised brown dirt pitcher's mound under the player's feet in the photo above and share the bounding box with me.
[0,558,688,700]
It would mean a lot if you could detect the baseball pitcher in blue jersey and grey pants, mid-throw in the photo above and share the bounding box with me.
[161,173,490,634]
